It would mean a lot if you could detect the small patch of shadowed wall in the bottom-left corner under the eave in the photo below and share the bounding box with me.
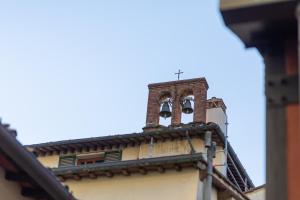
[0,167,29,200]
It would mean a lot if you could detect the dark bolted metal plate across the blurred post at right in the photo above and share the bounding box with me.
[266,75,299,106]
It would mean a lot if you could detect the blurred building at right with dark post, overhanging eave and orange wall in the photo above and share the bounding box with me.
[220,0,300,200]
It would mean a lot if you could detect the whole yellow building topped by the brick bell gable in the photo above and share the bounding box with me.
[28,78,262,200]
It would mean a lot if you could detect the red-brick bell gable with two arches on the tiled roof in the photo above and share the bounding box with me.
[145,78,208,128]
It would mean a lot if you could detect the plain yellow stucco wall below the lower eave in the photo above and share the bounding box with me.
[65,169,199,200]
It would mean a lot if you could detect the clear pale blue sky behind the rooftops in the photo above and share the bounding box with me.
[0,0,265,185]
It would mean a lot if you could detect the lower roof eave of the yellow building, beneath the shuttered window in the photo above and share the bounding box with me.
[52,153,248,200]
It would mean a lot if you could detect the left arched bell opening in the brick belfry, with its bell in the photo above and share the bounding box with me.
[159,93,172,126]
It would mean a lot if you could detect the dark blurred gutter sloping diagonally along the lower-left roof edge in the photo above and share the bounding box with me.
[0,124,74,200]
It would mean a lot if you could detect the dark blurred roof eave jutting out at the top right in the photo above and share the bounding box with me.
[221,0,297,48]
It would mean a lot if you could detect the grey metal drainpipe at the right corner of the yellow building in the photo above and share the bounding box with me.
[203,131,215,200]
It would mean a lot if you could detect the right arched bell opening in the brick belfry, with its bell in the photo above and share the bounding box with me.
[180,95,195,124]
